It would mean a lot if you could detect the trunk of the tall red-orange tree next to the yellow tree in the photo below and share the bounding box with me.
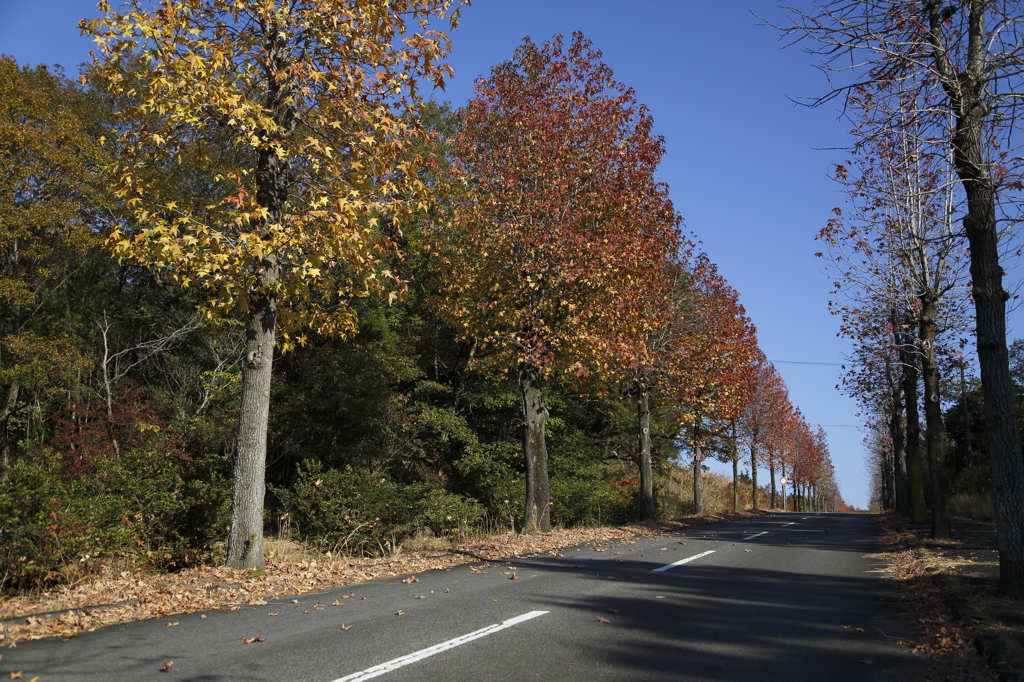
[519,363,551,534]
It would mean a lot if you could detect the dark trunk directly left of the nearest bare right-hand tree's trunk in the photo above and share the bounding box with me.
[919,295,949,538]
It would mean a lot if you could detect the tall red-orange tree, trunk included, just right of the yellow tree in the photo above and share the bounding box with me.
[426,33,678,532]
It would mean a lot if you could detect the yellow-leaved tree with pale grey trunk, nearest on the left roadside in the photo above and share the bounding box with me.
[80,0,460,568]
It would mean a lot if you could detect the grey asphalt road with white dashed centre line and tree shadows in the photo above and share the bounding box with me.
[0,513,925,682]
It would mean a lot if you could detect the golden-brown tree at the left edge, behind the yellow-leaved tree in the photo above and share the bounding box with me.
[0,56,100,481]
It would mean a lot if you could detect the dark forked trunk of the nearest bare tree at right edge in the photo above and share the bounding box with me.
[925,0,1024,598]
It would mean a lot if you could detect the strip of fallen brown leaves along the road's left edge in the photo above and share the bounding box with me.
[0,512,762,647]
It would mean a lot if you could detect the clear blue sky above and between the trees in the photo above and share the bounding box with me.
[6,0,999,507]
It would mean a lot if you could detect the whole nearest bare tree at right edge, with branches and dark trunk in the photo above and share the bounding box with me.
[780,0,1024,597]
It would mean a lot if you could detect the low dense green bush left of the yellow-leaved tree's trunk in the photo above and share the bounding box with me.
[0,449,228,591]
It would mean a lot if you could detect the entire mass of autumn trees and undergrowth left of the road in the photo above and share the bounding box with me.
[0,0,847,592]
